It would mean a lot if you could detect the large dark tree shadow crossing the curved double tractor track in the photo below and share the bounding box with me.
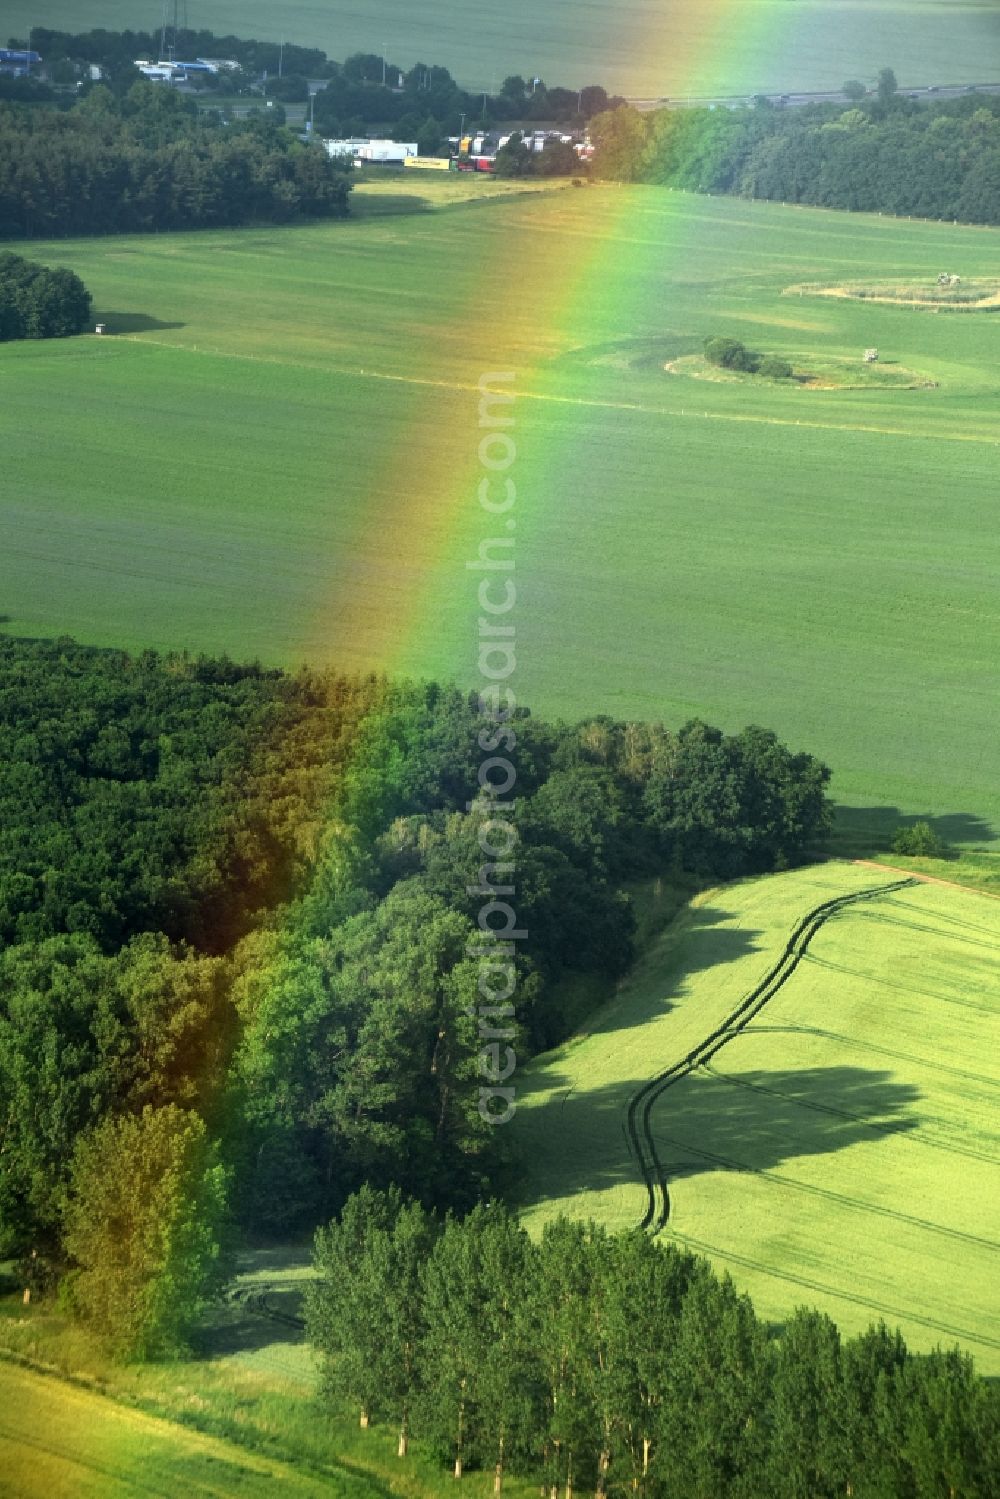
[511,1061,921,1222]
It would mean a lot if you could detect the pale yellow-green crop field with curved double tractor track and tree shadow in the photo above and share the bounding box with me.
[514,865,1000,1373]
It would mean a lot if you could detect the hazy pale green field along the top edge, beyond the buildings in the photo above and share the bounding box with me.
[4,0,1000,96]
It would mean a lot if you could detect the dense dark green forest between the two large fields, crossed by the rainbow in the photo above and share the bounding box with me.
[0,639,829,1264]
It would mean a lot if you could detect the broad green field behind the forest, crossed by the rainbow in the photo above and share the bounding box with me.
[0,180,1000,844]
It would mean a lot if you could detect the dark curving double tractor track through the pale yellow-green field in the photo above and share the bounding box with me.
[624,875,919,1234]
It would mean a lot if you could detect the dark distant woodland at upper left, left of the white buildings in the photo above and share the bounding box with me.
[0,81,349,238]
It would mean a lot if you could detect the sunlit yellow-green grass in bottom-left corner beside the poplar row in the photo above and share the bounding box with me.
[0,1277,538,1499]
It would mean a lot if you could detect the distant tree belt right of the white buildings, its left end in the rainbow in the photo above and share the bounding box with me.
[591,69,1000,225]
